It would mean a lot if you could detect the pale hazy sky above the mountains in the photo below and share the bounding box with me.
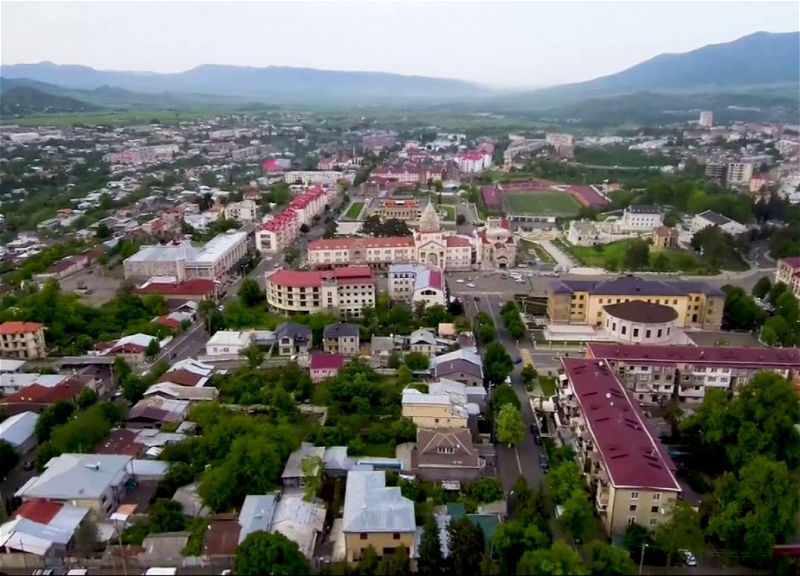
[0,0,800,86]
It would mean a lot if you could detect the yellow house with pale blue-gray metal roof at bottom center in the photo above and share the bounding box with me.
[342,470,416,563]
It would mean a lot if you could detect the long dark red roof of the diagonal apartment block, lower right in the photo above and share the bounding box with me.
[561,358,681,492]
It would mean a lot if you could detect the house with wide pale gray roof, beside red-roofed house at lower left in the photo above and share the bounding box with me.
[15,454,132,517]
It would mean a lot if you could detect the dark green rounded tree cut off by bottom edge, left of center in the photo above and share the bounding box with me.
[233,531,311,576]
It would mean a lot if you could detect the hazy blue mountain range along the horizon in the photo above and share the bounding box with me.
[0,32,800,114]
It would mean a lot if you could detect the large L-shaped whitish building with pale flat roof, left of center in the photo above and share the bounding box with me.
[123,230,247,282]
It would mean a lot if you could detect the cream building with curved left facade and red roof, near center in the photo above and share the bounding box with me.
[266,266,376,318]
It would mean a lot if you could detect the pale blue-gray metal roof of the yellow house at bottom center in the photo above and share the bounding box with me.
[342,470,416,532]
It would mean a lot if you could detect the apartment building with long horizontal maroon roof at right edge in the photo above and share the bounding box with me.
[586,343,800,404]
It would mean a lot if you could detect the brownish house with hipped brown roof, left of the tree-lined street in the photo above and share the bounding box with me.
[411,428,486,482]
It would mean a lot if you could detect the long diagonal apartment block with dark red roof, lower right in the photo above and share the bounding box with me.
[558,358,681,536]
